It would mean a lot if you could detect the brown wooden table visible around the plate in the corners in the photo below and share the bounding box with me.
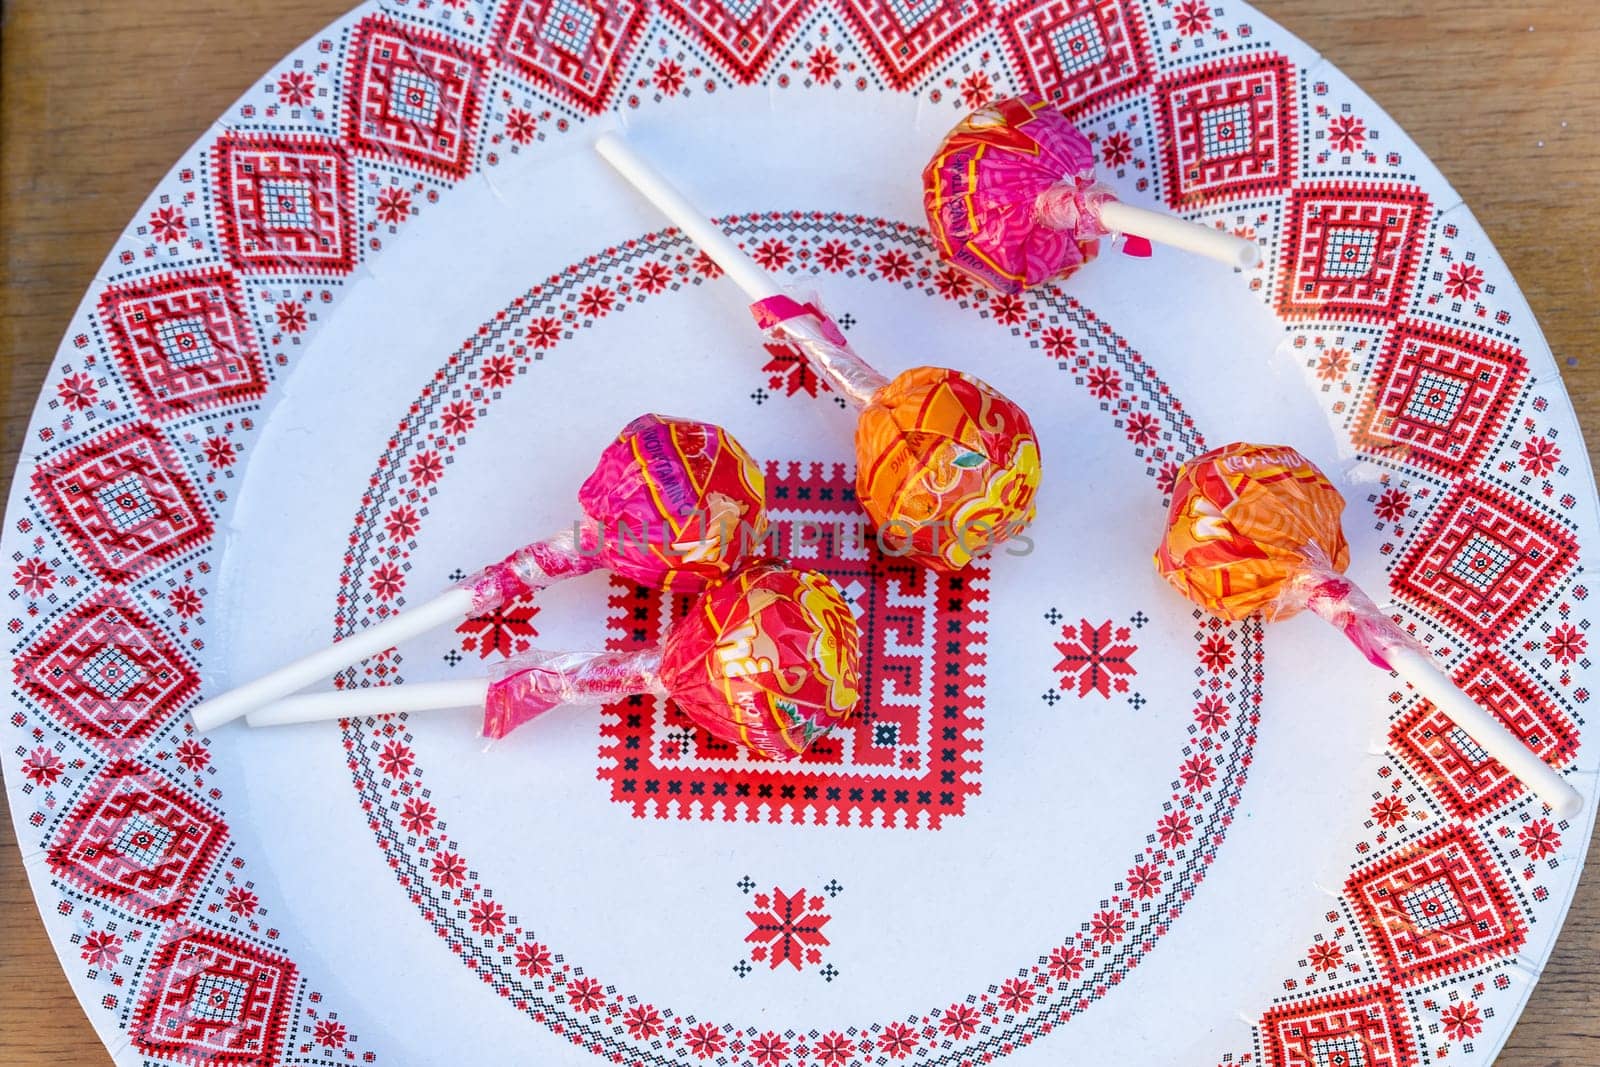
[0,0,1600,1067]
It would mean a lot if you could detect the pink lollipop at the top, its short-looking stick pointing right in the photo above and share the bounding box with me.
[922,96,1261,293]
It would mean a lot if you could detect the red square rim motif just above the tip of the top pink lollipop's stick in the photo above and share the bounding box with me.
[1155,54,1298,208]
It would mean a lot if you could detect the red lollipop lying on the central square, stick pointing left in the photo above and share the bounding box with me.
[246,561,861,760]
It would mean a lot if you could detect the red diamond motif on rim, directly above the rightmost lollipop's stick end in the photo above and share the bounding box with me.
[1389,482,1578,645]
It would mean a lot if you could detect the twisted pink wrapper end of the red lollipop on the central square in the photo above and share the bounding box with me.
[483,651,667,741]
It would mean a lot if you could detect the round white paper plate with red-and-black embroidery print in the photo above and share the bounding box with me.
[0,0,1600,1067]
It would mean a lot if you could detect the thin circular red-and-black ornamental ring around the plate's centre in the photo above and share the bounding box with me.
[336,213,1264,1067]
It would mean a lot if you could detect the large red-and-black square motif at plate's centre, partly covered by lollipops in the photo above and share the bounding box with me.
[600,464,987,829]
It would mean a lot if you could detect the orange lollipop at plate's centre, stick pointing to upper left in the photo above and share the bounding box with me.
[595,134,1040,571]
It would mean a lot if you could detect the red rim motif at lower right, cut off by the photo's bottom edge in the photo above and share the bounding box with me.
[1261,985,1418,1067]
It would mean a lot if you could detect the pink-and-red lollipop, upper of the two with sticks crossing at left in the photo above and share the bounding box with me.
[194,414,766,729]
